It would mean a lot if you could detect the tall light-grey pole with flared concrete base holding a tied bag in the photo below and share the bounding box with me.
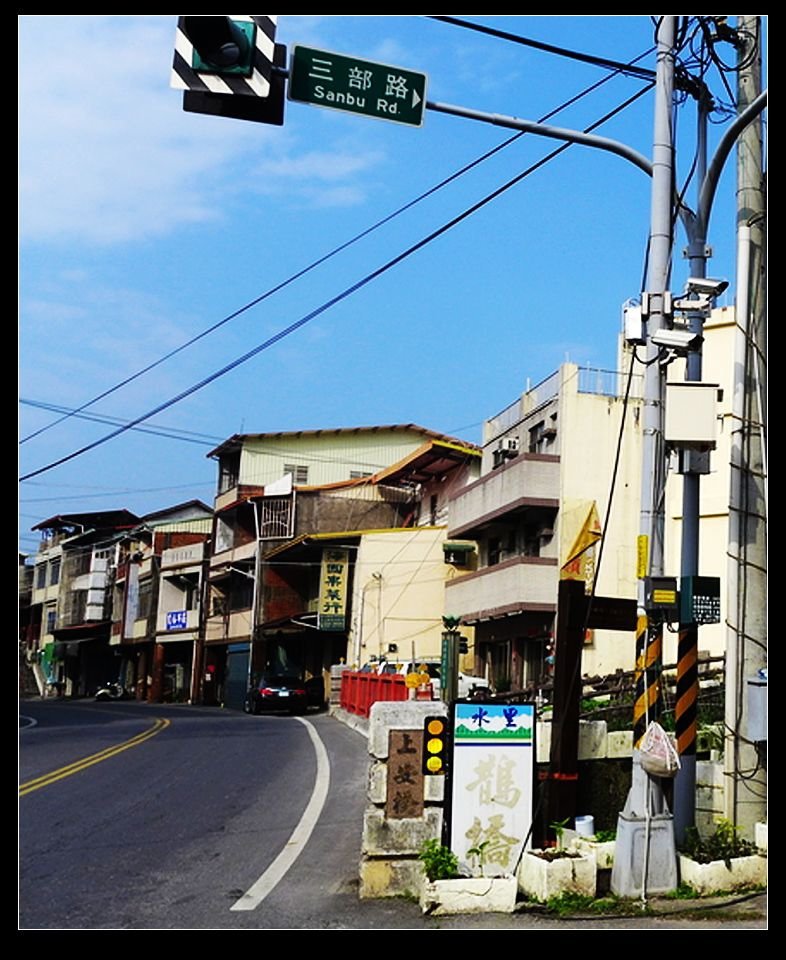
[611,16,678,897]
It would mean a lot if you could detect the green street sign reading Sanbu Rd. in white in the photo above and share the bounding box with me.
[288,46,426,127]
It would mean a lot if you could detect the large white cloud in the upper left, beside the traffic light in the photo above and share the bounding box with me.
[19,16,272,244]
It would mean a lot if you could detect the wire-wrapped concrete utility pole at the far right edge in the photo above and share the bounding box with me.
[724,16,767,838]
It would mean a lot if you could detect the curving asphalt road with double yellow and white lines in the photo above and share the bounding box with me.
[18,700,766,933]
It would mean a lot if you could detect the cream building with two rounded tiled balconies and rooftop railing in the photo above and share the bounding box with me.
[446,363,641,691]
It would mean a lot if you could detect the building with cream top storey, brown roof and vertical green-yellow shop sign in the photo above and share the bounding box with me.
[203,424,478,706]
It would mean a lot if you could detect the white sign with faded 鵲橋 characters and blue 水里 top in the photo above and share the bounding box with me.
[450,702,535,877]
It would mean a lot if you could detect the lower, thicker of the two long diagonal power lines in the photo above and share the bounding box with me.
[19,84,652,481]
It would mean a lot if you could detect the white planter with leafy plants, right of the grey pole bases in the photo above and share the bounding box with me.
[679,819,767,895]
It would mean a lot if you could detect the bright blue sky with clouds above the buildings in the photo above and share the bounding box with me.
[18,15,764,551]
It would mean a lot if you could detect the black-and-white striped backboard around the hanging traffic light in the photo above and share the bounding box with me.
[170,14,277,97]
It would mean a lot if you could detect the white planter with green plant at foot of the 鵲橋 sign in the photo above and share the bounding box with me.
[419,838,518,916]
